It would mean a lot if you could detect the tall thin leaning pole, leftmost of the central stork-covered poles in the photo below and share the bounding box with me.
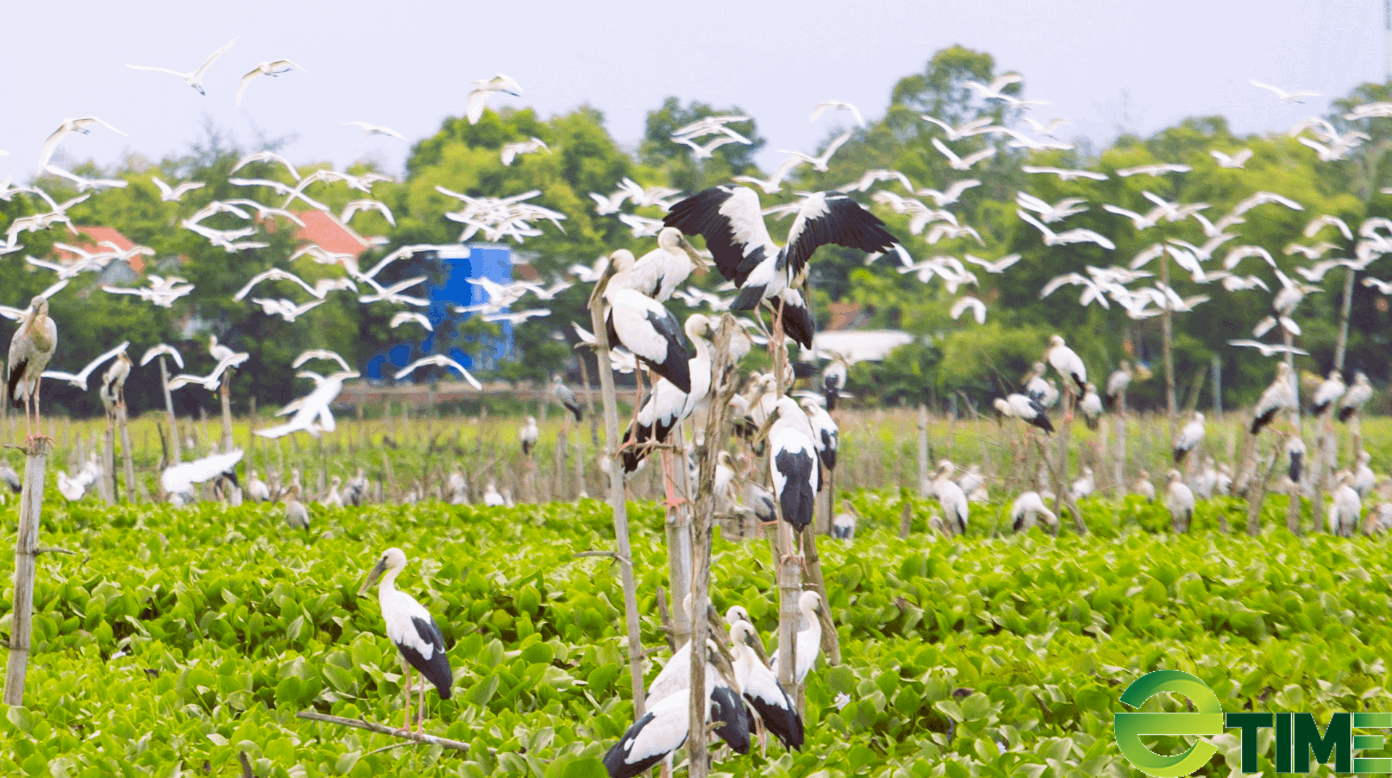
[589,264,647,721]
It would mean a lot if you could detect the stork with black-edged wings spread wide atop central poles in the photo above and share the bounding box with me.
[663,186,896,348]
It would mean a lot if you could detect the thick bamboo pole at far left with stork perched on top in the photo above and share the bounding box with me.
[4,440,49,706]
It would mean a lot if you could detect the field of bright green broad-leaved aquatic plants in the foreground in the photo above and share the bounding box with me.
[0,493,1392,778]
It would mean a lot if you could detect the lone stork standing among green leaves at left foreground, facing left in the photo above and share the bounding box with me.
[358,548,454,732]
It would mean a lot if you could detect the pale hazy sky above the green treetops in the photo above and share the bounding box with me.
[0,0,1384,184]
